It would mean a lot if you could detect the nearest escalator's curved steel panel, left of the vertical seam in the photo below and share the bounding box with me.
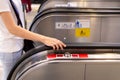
[17,61,85,80]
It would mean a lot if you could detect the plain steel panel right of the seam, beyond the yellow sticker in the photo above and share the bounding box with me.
[101,16,120,43]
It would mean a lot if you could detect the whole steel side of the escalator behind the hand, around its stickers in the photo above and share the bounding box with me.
[32,14,120,44]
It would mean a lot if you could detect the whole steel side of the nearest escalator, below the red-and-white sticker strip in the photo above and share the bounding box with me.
[11,49,120,80]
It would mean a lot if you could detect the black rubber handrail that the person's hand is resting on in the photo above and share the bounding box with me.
[7,43,120,80]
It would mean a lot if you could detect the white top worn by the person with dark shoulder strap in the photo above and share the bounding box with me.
[0,0,24,53]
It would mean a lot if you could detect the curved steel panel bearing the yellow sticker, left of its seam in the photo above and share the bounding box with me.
[31,14,101,44]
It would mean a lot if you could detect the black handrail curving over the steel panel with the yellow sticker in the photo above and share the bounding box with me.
[29,7,120,31]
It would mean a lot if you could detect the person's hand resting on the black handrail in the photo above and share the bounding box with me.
[42,37,66,50]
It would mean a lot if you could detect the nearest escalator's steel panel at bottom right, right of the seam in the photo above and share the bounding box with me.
[85,61,120,80]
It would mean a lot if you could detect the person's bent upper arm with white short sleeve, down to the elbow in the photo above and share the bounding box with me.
[0,0,15,31]
